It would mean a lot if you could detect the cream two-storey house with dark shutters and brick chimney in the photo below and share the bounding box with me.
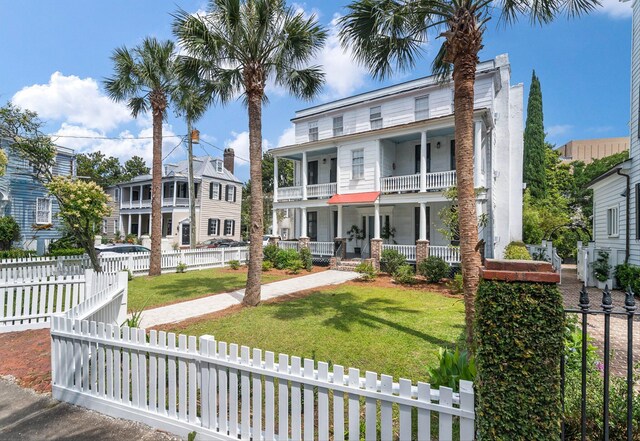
[102,149,242,246]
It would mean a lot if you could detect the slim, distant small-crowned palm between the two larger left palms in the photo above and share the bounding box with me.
[172,78,213,249]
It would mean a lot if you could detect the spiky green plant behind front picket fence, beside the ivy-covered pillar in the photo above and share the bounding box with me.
[427,348,476,392]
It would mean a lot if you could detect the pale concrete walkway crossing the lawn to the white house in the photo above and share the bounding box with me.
[140,270,359,328]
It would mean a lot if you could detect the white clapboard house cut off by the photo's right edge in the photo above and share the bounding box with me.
[578,0,640,285]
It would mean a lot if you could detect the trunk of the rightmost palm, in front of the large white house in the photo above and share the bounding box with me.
[453,46,481,349]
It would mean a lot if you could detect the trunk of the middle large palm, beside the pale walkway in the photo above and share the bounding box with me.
[242,87,264,306]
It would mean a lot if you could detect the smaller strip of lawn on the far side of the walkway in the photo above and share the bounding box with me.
[128,268,287,311]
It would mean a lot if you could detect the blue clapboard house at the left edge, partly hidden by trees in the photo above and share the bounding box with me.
[0,143,75,254]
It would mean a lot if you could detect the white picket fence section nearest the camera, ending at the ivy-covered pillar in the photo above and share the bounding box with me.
[51,316,474,441]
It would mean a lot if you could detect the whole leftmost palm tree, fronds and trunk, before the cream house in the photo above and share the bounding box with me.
[104,37,175,276]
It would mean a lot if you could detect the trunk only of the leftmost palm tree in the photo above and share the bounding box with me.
[149,102,164,276]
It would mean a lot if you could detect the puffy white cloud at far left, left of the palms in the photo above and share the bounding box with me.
[12,72,133,131]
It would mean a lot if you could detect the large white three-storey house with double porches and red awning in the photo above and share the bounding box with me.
[270,55,523,257]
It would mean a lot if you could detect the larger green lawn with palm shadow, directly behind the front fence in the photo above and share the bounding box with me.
[161,283,464,381]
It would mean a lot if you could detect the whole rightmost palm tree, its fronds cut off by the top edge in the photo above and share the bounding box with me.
[340,0,599,348]
